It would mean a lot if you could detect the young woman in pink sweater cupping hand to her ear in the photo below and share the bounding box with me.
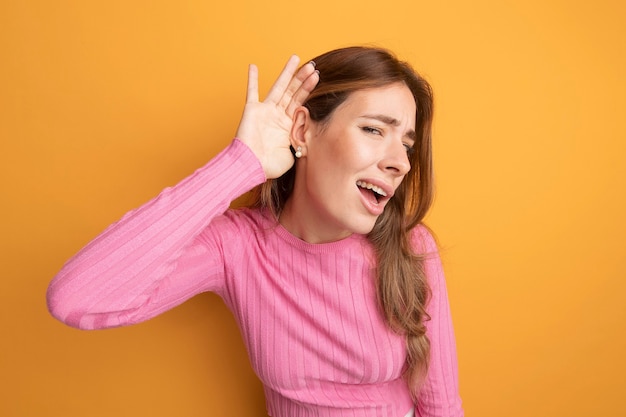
[48,47,463,417]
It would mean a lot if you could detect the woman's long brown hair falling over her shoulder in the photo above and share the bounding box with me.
[253,47,433,396]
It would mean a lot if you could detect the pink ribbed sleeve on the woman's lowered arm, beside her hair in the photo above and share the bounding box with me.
[416,228,464,417]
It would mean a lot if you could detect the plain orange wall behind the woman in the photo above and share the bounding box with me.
[0,0,626,417]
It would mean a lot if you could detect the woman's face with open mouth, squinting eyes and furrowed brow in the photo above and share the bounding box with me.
[290,83,416,243]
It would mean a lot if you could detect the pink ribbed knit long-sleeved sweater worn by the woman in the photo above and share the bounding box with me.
[48,140,463,417]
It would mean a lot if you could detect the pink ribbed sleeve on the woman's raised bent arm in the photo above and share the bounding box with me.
[47,139,265,329]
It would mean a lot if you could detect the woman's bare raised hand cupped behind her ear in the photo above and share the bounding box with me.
[237,55,319,179]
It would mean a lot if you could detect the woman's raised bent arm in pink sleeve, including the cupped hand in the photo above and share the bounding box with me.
[47,56,319,329]
